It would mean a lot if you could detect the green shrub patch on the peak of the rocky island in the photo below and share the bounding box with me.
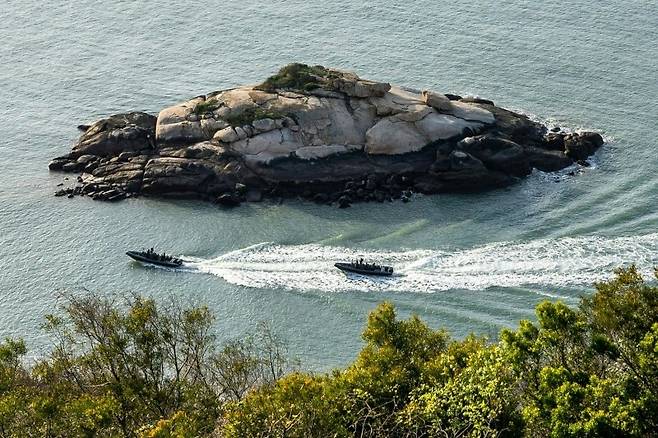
[256,63,340,91]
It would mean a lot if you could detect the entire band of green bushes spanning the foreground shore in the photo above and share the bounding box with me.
[0,268,658,437]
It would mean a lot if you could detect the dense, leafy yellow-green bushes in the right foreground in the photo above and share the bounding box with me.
[223,268,658,437]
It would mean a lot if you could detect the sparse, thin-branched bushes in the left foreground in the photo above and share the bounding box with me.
[0,295,287,437]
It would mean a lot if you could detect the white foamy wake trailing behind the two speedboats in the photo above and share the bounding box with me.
[179,233,658,296]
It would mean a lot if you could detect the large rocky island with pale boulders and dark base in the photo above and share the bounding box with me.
[49,64,603,207]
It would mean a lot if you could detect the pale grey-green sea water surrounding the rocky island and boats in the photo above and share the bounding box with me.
[0,0,658,369]
